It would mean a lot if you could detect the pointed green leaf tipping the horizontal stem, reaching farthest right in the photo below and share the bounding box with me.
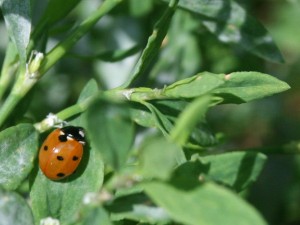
[214,72,290,103]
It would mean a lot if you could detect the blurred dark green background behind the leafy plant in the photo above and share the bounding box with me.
[0,0,300,224]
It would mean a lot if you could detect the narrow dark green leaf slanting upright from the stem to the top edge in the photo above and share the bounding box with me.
[122,0,178,88]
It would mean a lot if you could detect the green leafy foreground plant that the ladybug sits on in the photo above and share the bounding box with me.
[0,0,291,225]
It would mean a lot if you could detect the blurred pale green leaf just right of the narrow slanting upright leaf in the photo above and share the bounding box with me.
[150,10,203,83]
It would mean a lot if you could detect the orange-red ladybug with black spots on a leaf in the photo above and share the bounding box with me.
[39,126,85,180]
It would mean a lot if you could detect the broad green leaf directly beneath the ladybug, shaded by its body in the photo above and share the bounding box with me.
[30,128,104,224]
